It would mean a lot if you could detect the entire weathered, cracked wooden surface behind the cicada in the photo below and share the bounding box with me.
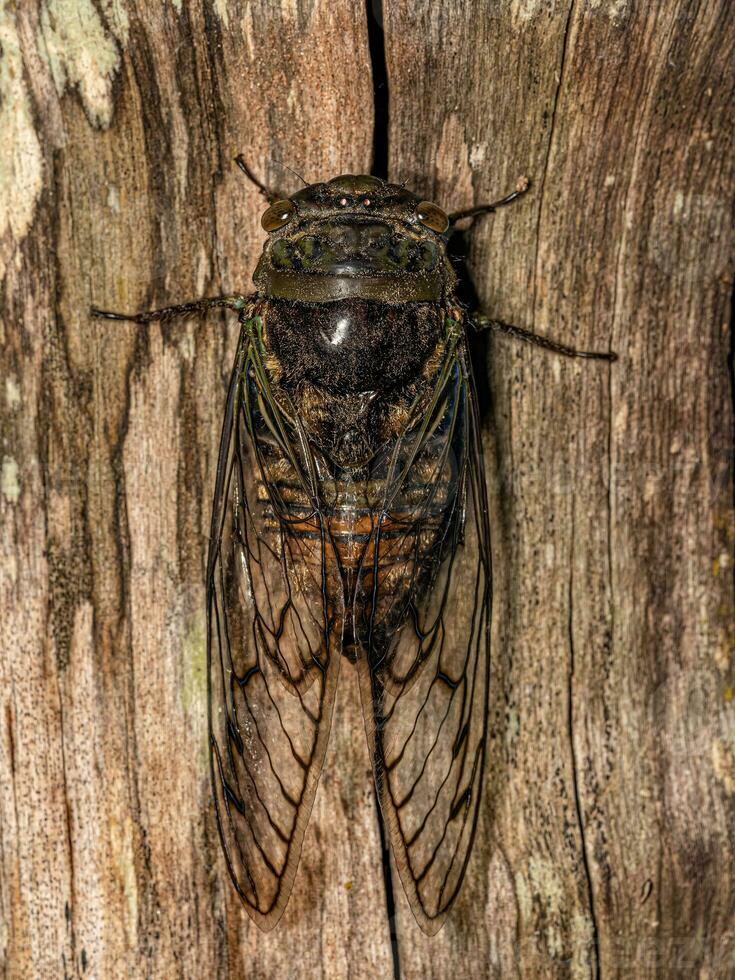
[0,0,735,980]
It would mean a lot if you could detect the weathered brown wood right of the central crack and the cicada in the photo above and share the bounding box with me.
[385,0,735,978]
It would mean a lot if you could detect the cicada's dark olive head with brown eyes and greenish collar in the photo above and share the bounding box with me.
[253,174,455,303]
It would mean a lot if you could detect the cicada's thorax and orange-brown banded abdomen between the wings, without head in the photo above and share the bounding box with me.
[247,299,460,660]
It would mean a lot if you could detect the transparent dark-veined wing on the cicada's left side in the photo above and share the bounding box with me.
[207,315,343,931]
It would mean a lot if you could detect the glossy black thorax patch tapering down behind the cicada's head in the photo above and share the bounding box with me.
[263,299,445,468]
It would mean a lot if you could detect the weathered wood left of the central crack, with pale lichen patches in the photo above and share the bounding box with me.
[0,0,390,978]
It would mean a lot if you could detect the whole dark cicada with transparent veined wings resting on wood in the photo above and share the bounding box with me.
[93,158,614,934]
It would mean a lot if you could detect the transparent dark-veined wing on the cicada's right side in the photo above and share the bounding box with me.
[354,340,492,935]
